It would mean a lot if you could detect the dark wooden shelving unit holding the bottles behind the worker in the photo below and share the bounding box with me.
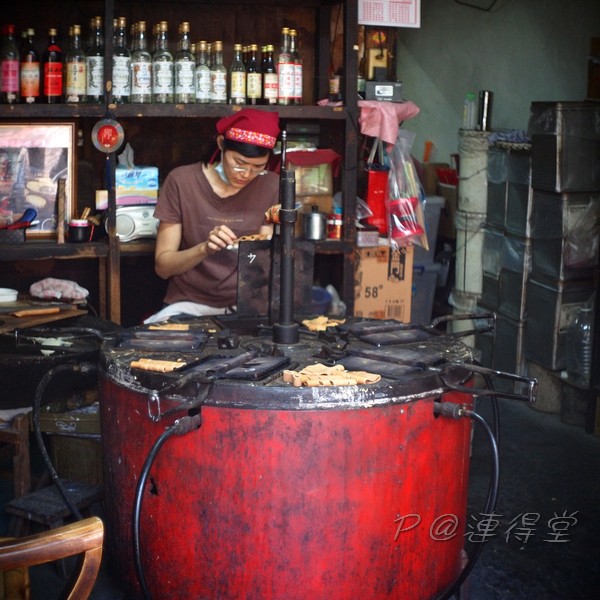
[0,0,358,322]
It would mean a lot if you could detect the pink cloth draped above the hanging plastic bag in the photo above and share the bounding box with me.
[358,100,420,144]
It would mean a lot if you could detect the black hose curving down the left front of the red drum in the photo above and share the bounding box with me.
[131,414,201,600]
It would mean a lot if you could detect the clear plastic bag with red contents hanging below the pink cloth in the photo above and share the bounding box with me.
[386,129,429,250]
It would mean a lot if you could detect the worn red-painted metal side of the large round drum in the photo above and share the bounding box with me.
[101,328,471,600]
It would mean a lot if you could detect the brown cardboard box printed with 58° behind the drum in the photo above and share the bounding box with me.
[354,246,413,323]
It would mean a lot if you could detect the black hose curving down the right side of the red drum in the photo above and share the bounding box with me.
[435,402,500,600]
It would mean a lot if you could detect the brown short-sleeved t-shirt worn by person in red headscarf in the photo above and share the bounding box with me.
[154,163,279,308]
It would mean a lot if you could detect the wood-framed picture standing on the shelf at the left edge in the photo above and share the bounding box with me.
[0,121,77,238]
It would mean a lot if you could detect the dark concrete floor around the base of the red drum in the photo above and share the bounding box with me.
[5,399,600,600]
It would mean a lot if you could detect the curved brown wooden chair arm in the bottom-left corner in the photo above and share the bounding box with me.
[0,517,104,600]
